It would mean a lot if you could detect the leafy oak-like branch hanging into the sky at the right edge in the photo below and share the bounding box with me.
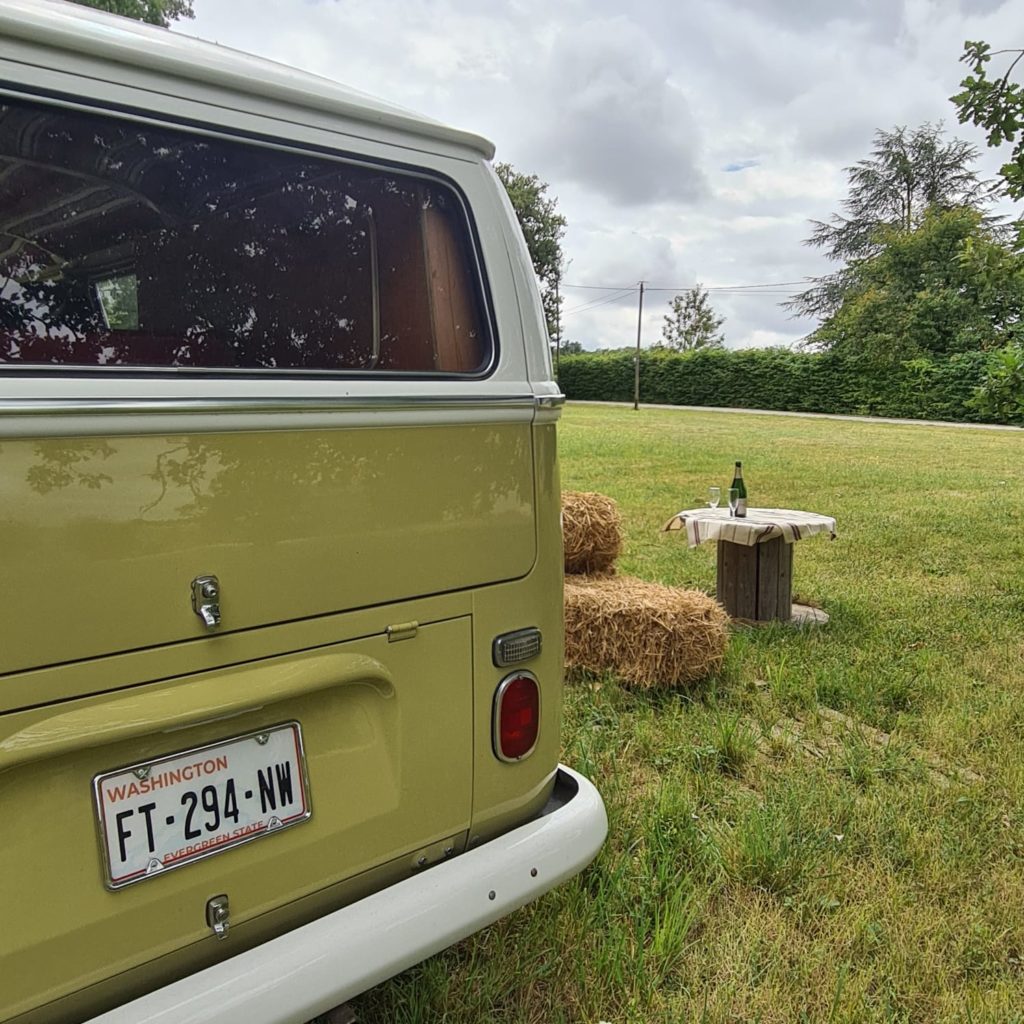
[949,40,1024,199]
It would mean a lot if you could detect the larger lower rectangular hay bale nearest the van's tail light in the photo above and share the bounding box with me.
[565,577,729,689]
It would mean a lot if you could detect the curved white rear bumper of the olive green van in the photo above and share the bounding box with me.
[89,766,608,1024]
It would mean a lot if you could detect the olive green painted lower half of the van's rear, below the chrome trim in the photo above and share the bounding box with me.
[0,424,561,1024]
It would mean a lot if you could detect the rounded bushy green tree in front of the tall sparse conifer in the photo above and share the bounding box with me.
[808,206,1024,361]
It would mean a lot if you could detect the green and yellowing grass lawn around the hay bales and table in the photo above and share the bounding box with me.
[355,407,1024,1024]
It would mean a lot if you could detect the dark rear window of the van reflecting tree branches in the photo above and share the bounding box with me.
[0,100,493,374]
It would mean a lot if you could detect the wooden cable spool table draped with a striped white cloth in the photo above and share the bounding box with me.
[665,508,836,623]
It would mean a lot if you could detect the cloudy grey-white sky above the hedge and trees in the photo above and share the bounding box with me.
[175,0,1024,349]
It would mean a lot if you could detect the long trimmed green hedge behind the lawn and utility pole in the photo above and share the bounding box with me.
[558,348,994,423]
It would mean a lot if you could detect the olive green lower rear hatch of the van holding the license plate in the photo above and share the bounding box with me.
[0,602,472,1021]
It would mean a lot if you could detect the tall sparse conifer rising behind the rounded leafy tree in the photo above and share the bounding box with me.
[786,124,991,316]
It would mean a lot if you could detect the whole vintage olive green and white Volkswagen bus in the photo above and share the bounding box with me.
[0,0,606,1024]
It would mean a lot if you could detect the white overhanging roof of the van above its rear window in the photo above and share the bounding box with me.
[0,0,495,160]
